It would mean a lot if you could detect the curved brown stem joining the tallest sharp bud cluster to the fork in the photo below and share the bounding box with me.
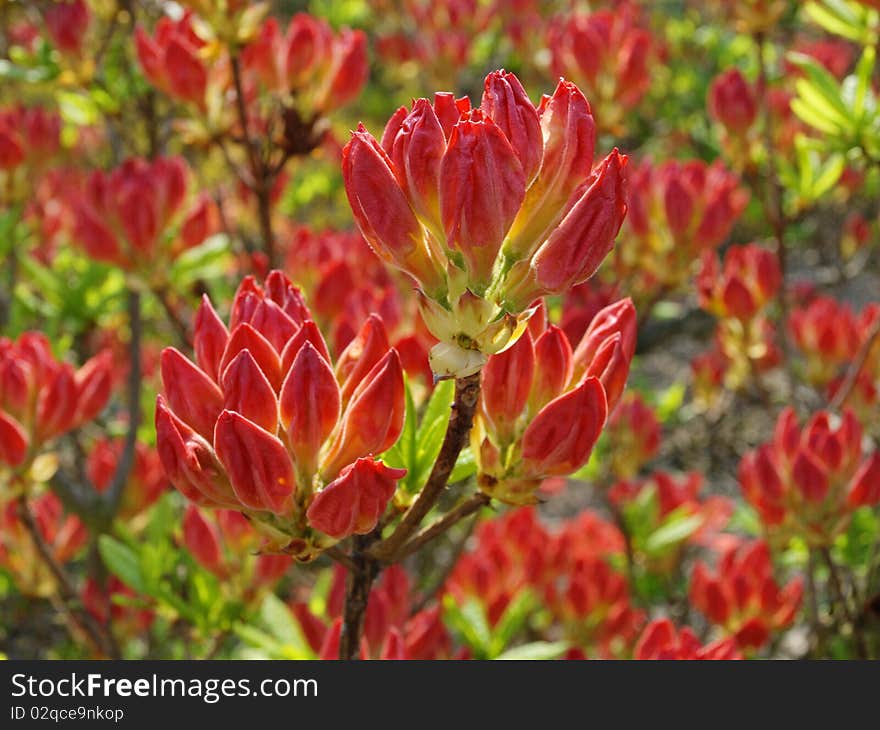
[369,372,480,563]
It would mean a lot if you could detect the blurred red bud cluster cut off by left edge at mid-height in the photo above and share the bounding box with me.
[0,332,111,468]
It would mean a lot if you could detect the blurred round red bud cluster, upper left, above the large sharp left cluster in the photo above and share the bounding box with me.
[73,157,212,276]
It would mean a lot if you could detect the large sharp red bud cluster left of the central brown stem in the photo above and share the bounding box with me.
[156,271,405,560]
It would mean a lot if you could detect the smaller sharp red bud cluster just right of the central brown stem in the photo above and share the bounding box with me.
[471,299,636,504]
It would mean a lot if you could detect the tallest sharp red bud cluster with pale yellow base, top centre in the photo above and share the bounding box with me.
[343,71,627,376]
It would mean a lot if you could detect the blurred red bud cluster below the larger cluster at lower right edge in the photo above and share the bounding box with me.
[690,540,803,650]
